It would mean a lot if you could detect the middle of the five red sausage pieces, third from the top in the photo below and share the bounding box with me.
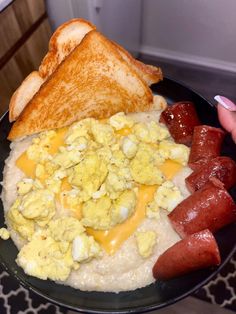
[185,156,236,193]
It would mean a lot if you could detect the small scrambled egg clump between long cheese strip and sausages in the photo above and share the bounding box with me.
[147,181,184,218]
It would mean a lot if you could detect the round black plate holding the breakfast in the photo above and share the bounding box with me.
[0,78,236,313]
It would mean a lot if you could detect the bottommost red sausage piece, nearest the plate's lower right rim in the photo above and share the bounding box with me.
[153,229,221,280]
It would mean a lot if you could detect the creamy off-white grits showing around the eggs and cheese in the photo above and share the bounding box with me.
[2,111,191,292]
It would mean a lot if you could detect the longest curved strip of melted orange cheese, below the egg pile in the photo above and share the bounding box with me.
[87,185,157,254]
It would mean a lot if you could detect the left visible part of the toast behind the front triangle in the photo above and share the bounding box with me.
[9,19,96,122]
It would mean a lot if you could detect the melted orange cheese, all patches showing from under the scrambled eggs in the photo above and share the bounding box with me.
[16,119,182,254]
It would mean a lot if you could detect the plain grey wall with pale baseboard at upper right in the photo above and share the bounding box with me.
[141,0,236,72]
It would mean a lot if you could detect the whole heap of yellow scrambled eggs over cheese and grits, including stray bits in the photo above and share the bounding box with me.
[10,108,189,281]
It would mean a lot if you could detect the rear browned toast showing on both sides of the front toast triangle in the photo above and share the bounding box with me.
[9,19,162,122]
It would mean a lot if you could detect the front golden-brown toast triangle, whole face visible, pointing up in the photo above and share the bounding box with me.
[8,30,153,140]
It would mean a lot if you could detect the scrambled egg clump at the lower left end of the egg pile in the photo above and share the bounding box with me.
[17,217,101,281]
